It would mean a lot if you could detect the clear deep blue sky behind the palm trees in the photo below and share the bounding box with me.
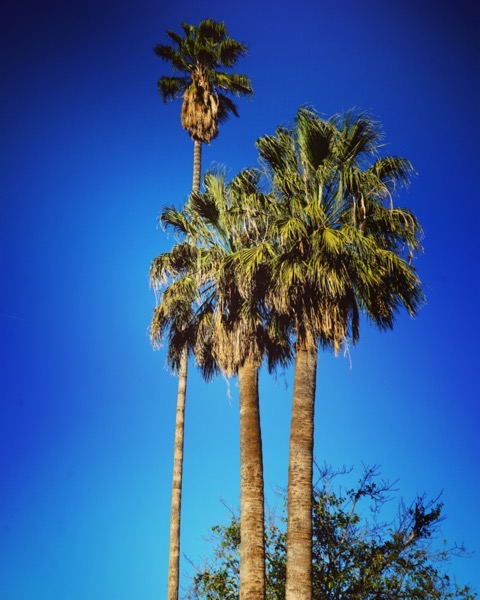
[0,0,480,600]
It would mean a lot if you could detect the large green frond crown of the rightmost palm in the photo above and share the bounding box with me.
[257,107,423,352]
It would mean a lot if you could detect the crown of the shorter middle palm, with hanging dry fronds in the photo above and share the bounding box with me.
[150,169,291,379]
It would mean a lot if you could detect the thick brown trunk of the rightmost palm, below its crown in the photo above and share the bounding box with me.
[285,348,317,600]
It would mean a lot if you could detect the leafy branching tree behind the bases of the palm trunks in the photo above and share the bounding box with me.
[186,467,477,600]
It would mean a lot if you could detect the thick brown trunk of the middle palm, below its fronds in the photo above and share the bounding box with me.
[238,362,265,600]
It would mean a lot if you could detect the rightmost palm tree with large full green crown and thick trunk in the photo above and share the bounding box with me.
[251,108,423,600]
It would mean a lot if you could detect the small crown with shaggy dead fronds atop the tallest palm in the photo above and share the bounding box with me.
[154,19,253,143]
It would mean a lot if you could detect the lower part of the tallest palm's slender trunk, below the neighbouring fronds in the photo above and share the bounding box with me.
[168,350,188,600]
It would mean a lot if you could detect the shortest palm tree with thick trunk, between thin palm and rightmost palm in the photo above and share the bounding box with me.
[151,170,290,600]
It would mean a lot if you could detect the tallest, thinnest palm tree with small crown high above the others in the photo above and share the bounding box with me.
[154,19,253,600]
